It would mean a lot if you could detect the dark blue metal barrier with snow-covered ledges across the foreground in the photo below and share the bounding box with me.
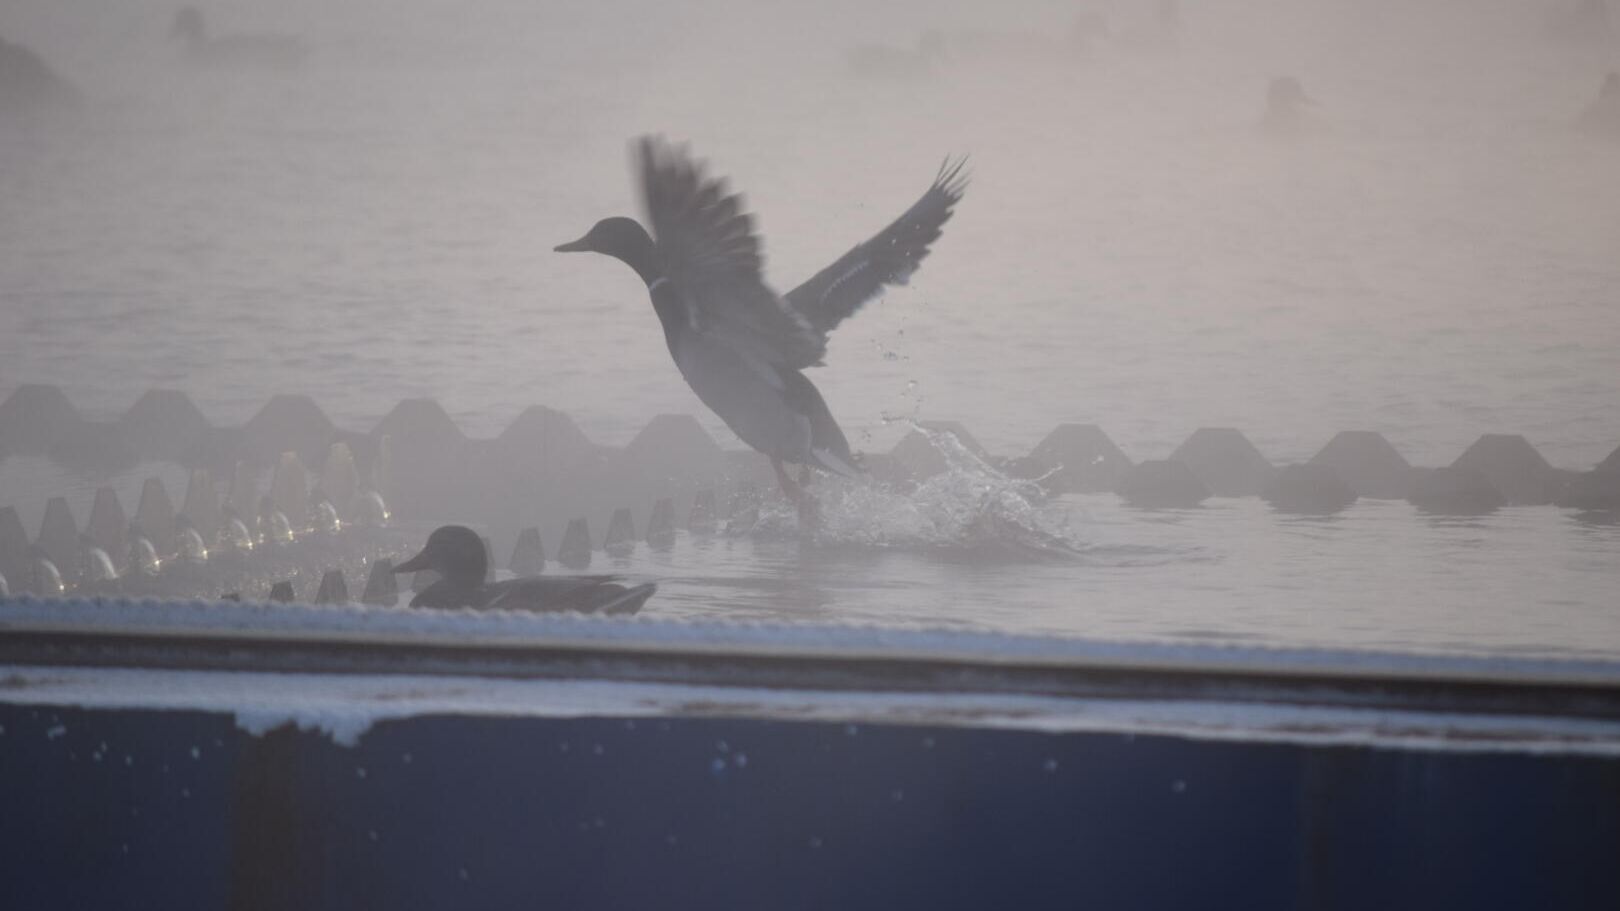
[0,601,1620,911]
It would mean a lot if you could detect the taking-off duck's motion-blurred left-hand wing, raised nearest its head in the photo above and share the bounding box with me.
[640,136,826,368]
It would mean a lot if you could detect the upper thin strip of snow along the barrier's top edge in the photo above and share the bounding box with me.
[0,597,1620,689]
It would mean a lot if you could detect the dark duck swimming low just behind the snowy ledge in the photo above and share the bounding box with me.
[394,525,658,614]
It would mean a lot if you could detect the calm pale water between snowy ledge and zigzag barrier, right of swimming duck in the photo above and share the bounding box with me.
[608,494,1620,657]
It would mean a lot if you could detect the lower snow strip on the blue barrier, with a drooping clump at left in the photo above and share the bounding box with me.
[0,666,1620,757]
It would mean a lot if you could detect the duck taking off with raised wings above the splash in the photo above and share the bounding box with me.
[556,138,967,517]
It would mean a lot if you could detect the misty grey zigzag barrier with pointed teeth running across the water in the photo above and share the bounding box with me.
[0,386,1620,592]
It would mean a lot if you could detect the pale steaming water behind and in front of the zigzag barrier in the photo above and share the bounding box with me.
[0,0,1620,655]
